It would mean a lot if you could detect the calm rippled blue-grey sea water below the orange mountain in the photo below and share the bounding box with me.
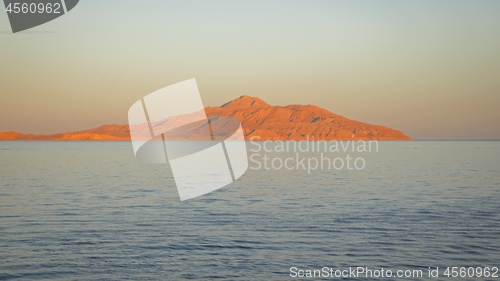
[0,142,500,280]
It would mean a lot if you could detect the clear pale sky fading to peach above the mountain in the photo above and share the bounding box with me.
[0,0,500,140]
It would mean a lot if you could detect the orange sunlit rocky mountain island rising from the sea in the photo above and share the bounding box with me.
[0,96,411,141]
